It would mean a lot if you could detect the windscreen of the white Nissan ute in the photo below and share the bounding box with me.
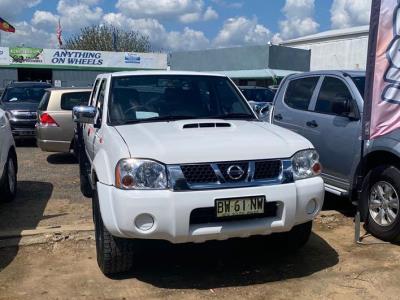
[108,75,256,125]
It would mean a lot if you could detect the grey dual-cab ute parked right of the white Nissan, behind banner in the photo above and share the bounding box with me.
[272,71,400,241]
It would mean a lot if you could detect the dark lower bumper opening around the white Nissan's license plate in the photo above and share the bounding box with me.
[190,202,278,225]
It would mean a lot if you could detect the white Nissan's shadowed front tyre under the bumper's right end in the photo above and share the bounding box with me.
[276,221,312,252]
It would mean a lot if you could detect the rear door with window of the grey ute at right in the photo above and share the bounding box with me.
[272,76,320,135]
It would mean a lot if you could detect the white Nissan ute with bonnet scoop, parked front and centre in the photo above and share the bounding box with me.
[73,71,324,274]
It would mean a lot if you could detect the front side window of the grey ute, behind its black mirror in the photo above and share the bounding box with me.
[315,77,354,116]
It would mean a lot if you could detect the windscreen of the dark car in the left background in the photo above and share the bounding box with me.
[2,86,50,103]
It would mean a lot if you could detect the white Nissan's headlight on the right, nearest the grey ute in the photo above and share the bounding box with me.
[292,149,322,180]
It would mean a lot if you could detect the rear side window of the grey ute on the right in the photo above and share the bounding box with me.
[284,77,319,110]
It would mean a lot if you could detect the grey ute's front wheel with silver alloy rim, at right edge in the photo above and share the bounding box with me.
[360,165,400,242]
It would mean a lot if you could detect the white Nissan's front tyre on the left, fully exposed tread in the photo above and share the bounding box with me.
[93,191,133,275]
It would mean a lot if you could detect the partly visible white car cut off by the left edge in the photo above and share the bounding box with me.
[0,109,18,202]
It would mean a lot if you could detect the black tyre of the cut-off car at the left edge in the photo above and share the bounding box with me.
[0,152,18,202]
